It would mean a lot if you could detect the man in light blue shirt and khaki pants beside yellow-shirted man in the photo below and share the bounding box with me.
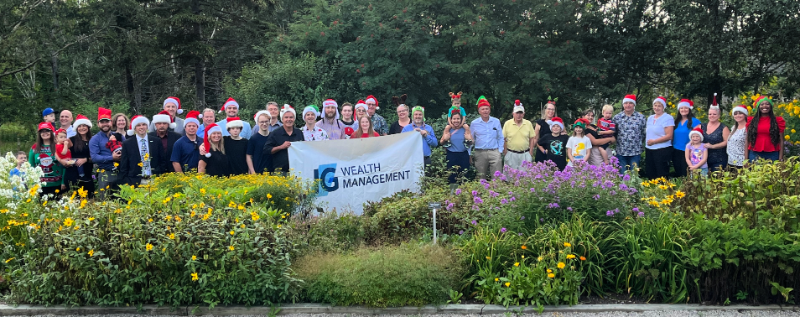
[470,96,504,179]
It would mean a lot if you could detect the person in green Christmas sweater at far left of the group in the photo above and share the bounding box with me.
[28,122,66,197]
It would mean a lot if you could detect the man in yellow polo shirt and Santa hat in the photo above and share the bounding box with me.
[503,100,536,169]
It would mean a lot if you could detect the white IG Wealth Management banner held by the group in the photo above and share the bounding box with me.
[289,133,424,215]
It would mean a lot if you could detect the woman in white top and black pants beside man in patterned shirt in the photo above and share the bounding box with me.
[644,96,675,179]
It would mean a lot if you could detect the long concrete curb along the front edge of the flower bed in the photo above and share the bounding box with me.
[0,304,800,316]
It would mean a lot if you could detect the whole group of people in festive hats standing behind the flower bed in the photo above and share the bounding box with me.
[17,92,785,197]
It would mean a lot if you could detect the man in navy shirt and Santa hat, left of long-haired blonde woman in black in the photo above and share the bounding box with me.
[170,110,203,173]
